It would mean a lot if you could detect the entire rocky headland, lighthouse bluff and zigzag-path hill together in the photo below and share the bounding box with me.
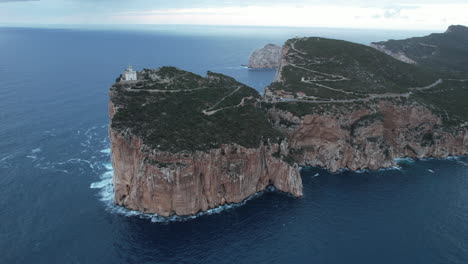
[109,26,468,216]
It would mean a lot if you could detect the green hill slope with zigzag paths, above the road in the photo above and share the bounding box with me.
[270,38,439,100]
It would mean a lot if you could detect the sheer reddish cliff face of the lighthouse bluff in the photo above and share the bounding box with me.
[109,102,302,216]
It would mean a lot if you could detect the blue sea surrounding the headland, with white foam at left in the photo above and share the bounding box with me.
[0,26,468,264]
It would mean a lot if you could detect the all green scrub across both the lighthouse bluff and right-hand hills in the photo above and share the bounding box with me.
[111,28,468,156]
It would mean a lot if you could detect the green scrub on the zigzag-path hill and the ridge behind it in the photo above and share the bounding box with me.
[268,35,468,127]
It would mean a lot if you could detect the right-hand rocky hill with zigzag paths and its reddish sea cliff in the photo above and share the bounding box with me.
[263,38,468,171]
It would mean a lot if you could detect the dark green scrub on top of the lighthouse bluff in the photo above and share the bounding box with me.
[111,68,281,152]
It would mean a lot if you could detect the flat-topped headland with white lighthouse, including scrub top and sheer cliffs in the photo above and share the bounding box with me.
[109,67,302,216]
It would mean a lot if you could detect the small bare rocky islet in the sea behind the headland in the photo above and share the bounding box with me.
[249,44,281,69]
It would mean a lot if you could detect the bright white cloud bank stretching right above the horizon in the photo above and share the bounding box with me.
[106,3,468,29]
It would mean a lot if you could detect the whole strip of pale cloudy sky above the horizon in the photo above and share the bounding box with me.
[0,0,468,30]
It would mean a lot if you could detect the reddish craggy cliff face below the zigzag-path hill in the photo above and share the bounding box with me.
[271,102,468,171]
